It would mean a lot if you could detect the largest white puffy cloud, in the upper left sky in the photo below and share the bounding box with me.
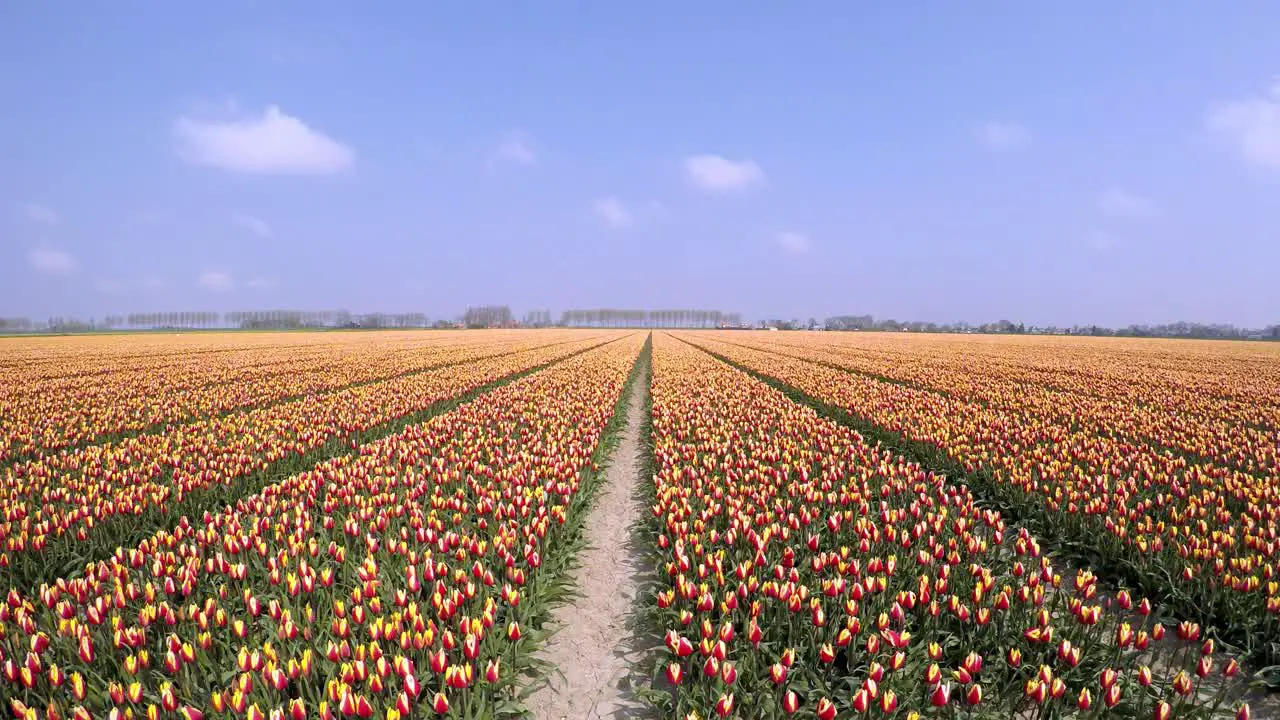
[173,105,356,174]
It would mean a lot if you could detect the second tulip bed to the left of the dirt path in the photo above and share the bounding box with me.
[0,333,617,587]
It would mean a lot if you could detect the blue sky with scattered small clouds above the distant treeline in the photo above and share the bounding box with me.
[0,0,1280,325]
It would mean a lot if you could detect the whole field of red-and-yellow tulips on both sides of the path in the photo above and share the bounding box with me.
[0,329,1280,720]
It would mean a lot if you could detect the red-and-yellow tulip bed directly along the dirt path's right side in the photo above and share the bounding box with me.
[652,336,1249,720]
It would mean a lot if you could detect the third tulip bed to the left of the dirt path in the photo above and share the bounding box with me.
[0,333,570,462]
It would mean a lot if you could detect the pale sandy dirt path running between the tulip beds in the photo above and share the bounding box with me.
[526,358,649,720]
